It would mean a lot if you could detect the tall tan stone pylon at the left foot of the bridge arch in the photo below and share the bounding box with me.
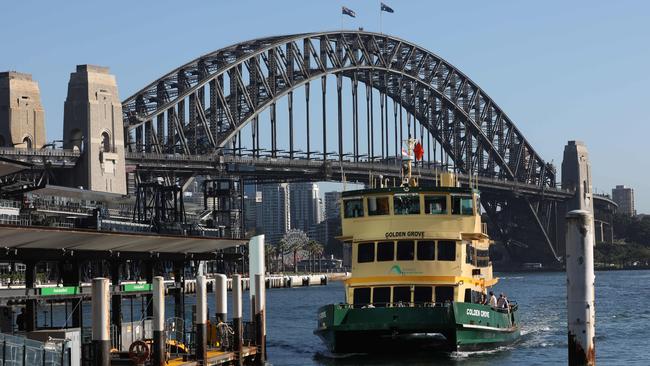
[63,65,126,194]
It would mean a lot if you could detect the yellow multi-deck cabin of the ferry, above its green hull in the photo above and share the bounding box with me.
[341,177,497,308]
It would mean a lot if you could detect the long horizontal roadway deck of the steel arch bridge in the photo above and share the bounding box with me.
[0,148,573,201]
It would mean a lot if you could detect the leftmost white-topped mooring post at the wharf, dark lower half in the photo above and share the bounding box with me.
[92,278,111,366]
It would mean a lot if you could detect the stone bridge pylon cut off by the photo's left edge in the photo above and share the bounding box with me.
[0,71,45,149]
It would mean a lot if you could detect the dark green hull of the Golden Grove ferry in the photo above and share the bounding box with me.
[314,303,519,353]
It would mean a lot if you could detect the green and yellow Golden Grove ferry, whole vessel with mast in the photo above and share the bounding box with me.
[314,139,520,353]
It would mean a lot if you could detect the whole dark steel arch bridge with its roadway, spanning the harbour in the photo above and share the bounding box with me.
[2,30,611,261]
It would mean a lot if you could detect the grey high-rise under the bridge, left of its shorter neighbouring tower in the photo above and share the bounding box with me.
[256,183,291,244]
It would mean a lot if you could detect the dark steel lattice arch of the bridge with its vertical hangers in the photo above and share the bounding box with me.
[123,31,558,257]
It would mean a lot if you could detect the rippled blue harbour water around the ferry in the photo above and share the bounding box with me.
[267,271,650,366]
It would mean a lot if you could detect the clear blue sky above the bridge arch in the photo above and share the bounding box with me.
[0,0,650,213]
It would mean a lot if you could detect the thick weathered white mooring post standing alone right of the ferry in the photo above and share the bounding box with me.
[566,210,596,366]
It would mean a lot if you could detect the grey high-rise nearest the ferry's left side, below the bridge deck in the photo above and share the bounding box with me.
[289,183,323,233]
